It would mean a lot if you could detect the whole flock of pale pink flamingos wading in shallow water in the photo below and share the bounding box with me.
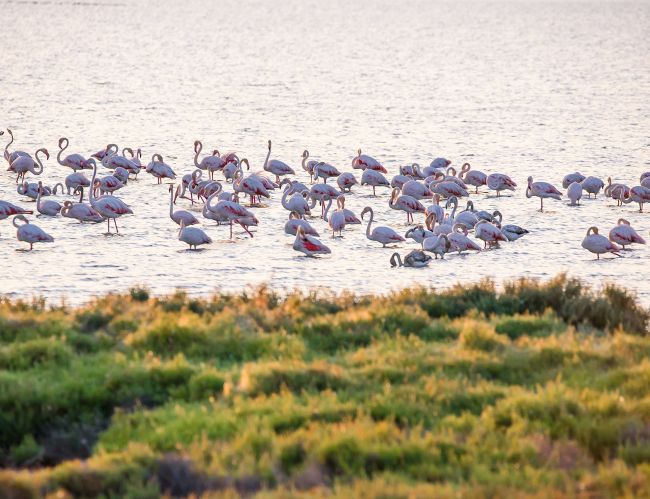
[0,130,650,267]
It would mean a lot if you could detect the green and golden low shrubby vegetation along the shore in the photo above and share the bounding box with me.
[0,276,650,498]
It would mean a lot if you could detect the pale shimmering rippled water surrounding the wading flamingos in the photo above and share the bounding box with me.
[0,0,650,304]
